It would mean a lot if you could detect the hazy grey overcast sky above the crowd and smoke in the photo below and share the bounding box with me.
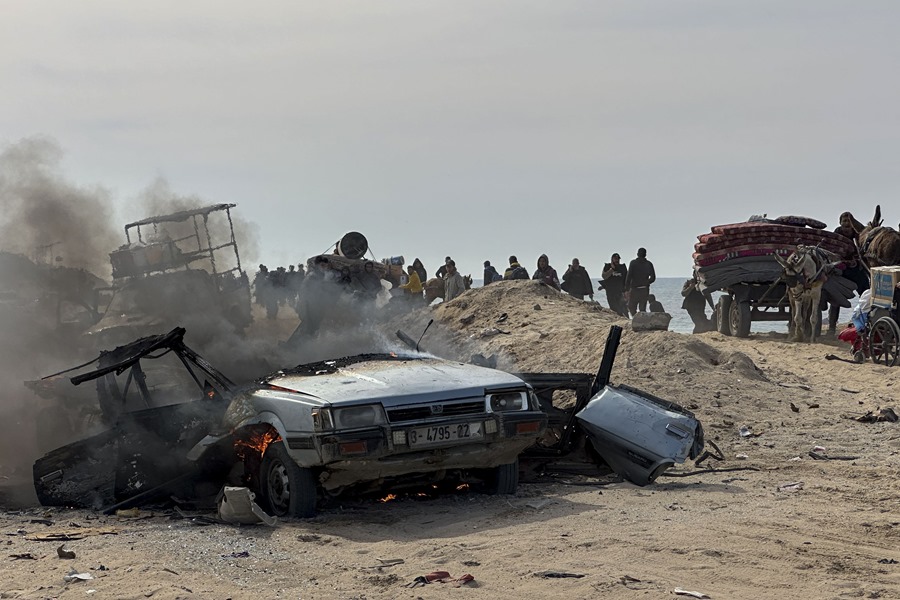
[0,0,900,278]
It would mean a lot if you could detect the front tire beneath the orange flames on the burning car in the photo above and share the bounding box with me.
[259,442,318,519]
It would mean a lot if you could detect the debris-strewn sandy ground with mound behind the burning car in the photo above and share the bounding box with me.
[0,282,900,599]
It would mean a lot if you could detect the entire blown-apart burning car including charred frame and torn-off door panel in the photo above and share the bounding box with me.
[34,326,704,517]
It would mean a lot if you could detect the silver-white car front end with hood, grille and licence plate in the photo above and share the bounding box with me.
[220,354,547,517]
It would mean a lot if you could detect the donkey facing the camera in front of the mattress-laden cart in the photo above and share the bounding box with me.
[773,245,827,342]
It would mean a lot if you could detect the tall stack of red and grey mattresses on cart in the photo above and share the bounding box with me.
[693,216,856,306]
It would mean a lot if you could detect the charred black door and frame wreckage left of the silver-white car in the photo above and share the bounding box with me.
[30,328,234,508]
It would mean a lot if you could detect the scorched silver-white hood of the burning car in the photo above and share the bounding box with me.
[265,358,527,407]
